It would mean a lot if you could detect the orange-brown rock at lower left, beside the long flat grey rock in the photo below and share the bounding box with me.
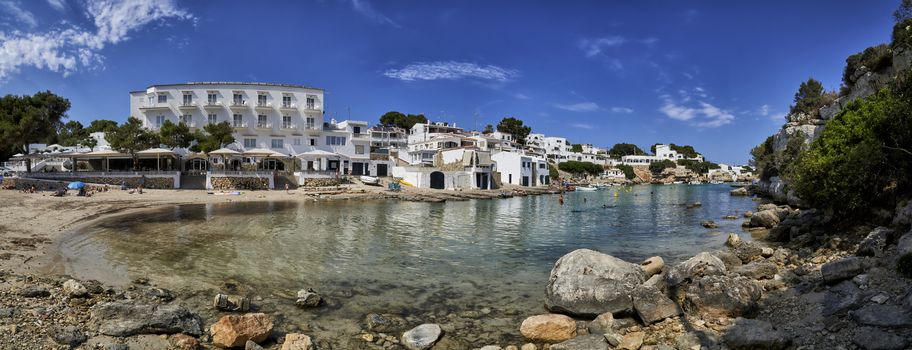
[209,313,273,348]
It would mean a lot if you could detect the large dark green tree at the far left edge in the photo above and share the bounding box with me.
[0,91,70,158]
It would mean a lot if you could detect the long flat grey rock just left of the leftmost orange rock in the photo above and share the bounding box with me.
[91,300,203,336]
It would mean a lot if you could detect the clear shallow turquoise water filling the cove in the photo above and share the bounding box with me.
[60,185,755,346]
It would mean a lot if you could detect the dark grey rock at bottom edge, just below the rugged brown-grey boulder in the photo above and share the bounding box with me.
[722,318,791,350]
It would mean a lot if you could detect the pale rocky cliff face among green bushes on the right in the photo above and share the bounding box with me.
[757,47,912,206]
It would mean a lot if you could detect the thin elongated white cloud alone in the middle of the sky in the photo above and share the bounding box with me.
[383,61,519,82]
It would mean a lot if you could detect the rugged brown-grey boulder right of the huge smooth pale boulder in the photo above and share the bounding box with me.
[685,276,763,317]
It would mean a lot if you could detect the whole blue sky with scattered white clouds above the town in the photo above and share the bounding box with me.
[0,0,898,163]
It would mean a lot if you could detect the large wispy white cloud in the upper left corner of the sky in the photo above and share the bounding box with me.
[0,0,195,80]
